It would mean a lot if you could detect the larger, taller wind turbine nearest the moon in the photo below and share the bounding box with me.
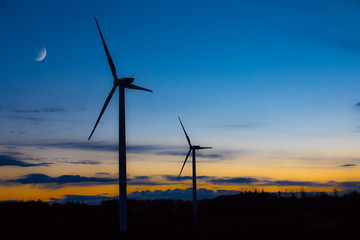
[88,18,152,232]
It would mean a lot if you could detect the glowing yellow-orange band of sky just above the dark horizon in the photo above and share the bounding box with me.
[0,144,360,201]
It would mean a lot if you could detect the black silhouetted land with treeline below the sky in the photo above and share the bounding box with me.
[0,192,360,240]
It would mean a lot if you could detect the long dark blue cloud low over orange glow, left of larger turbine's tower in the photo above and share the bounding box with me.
[7,173,118,185]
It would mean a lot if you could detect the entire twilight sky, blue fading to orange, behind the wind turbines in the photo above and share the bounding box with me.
[0,0,360,201]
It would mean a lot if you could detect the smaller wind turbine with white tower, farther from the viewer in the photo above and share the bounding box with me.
[178,117,212,222]
